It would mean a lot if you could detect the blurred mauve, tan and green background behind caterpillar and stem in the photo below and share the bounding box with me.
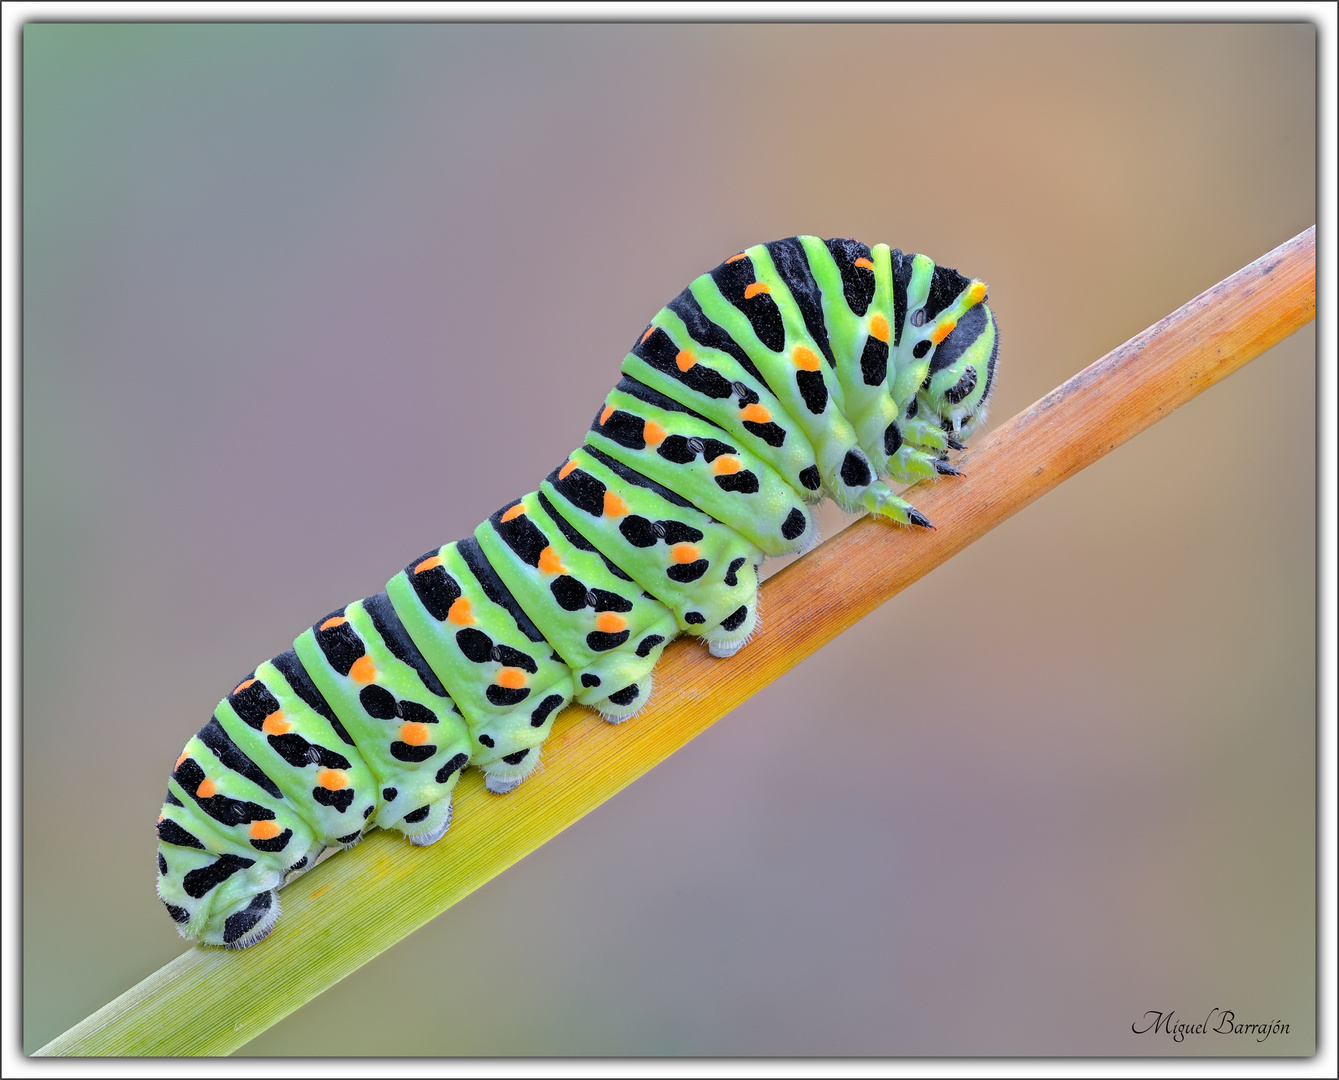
[23,24,1316,1056]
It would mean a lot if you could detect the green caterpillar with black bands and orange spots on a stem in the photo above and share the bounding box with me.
[157,236,999,949]
